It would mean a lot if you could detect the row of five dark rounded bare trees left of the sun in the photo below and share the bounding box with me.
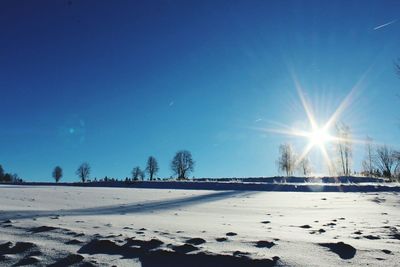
[52,150,195,183]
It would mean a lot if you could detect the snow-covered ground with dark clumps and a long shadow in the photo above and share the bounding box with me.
[0,186,400,267]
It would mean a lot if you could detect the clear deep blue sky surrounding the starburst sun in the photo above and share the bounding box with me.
[0,0,400,181]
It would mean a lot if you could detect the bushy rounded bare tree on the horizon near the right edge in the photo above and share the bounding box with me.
[374,145,396,179]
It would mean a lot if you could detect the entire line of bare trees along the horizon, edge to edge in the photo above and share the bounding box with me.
[0,141,400,183]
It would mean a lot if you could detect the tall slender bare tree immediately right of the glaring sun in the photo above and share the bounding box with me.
[336,123,352,176]
